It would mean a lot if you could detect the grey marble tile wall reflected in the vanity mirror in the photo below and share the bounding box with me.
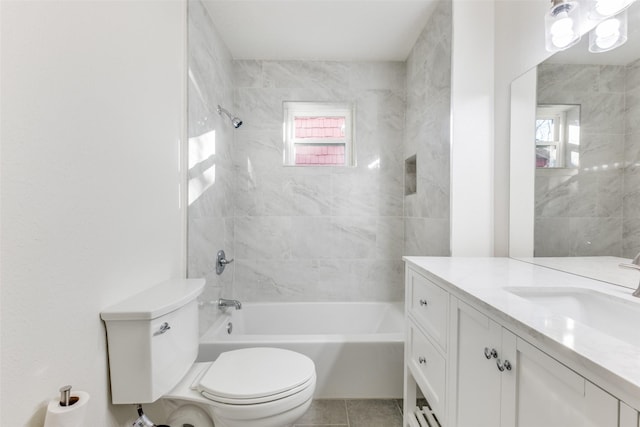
[535,62,640,258]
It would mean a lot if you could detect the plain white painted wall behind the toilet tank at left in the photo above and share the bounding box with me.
[0,1,186,427]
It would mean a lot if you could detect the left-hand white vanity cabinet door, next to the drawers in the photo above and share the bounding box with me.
[452,301,502,427]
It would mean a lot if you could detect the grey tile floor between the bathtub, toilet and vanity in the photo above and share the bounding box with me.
[294,399,402,427]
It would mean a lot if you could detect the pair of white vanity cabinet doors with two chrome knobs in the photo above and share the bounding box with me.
[452,301,618,427]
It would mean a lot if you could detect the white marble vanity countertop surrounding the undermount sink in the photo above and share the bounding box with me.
[403,256,640,410]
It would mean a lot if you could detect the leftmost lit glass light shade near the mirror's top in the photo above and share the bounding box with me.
[544,0,581,52]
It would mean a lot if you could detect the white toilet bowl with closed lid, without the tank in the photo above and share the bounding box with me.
[164,347,316,427]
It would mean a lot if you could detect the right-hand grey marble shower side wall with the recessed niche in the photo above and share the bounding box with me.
[403,1,452,255]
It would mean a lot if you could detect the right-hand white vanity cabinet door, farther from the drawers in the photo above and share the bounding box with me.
[496,338,618,427]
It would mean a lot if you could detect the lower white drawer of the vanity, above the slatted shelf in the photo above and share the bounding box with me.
[407,322,447,423]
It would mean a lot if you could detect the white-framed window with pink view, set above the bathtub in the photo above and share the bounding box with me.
[284,102,356,166]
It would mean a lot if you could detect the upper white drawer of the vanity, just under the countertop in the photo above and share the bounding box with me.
[407,270,449,351]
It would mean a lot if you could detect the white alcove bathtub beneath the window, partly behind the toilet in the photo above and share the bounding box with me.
[198,302,404,399]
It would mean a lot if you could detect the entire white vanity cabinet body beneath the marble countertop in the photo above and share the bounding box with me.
[404,267,628,427]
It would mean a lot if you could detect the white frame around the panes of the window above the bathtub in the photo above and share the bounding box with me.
[283,101,356,167]
